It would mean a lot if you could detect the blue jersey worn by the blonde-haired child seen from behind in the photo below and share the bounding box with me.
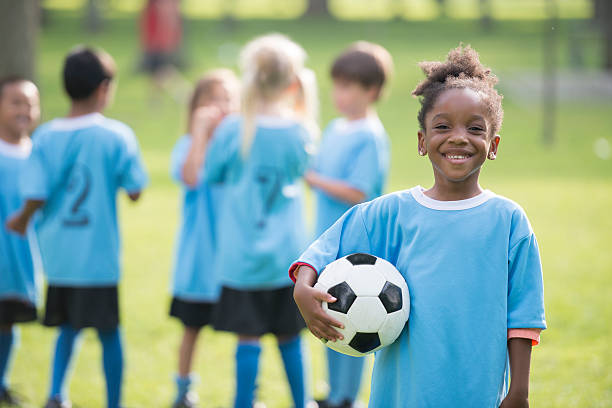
[205,115,310,289]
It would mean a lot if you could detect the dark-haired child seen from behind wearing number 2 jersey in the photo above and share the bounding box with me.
[8,47,147,408]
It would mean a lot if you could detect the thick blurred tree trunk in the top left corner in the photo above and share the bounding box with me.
[0,0,39,80]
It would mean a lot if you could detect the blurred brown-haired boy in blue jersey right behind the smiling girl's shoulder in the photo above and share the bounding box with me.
[305,41,393,408]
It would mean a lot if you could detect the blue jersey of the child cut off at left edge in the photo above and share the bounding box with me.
[0,139,37,304]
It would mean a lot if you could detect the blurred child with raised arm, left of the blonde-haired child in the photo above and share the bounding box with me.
[170,69,239,408]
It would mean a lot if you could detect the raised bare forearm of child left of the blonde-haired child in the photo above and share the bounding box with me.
[181,106,224,187]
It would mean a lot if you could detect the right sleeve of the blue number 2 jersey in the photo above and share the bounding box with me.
[117,130,148,193]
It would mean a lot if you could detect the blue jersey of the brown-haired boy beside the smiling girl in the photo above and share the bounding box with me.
[314,116,389,235]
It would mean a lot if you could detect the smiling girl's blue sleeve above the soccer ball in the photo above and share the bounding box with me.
[292,206,372,273]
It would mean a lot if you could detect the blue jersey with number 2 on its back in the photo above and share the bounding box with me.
[21,113,147,286]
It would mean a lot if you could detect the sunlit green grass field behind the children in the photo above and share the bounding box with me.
[12,7,612,407]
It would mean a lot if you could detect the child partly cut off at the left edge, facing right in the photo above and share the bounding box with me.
[0,76,40,406]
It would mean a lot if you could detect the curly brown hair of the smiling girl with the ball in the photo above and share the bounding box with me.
[412,45,504,136]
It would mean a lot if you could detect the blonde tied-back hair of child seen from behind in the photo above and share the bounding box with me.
[240,34,312,156]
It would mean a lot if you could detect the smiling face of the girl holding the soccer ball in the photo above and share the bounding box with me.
[418,88,500,188]
